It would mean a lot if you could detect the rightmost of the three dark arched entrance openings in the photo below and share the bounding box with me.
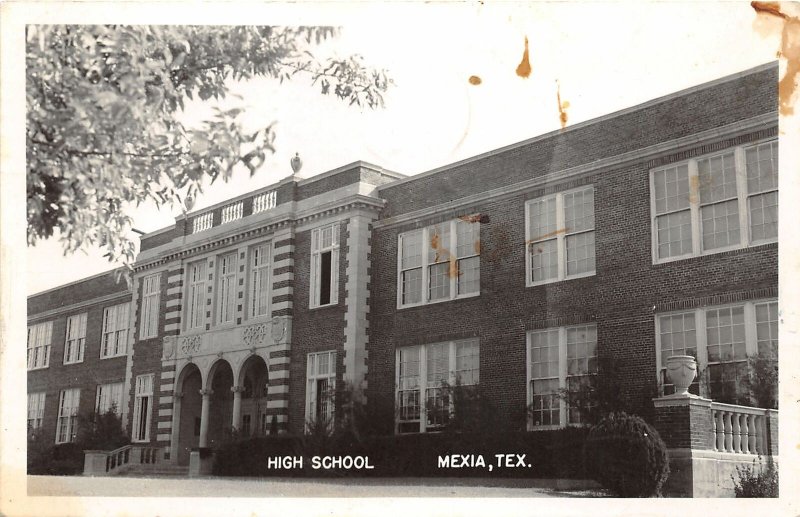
[238,354,271,436]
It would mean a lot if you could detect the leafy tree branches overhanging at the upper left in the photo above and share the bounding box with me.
[25,25,391,263]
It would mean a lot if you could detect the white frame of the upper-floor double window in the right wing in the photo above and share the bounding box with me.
[525,185,597,287]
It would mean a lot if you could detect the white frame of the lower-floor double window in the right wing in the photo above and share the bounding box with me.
[525,323,598,431]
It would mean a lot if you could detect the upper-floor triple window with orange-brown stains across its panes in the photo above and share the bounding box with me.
[397,217,481,307]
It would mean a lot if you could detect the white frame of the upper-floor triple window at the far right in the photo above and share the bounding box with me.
[650,138,780,264]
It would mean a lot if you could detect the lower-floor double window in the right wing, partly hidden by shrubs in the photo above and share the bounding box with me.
[528,324,597,429]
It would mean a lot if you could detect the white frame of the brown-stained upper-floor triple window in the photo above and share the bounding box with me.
[397,215,481,309]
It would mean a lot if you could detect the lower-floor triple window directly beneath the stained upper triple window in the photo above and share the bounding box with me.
[396,339,480,433]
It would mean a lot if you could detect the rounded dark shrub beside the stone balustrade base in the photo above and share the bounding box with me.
[584,413,669,497]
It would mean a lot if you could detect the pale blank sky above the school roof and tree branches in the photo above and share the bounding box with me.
[25,2,779,294]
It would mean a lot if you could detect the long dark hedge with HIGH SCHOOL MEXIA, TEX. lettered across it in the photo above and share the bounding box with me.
[213,428,588,479]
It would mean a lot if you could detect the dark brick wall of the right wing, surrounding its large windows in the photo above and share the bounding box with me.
[368,103,778,430]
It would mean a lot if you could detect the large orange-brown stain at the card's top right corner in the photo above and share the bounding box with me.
[750,2,800,116]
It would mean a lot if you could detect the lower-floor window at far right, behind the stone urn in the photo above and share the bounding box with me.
[656,300,778,404]
